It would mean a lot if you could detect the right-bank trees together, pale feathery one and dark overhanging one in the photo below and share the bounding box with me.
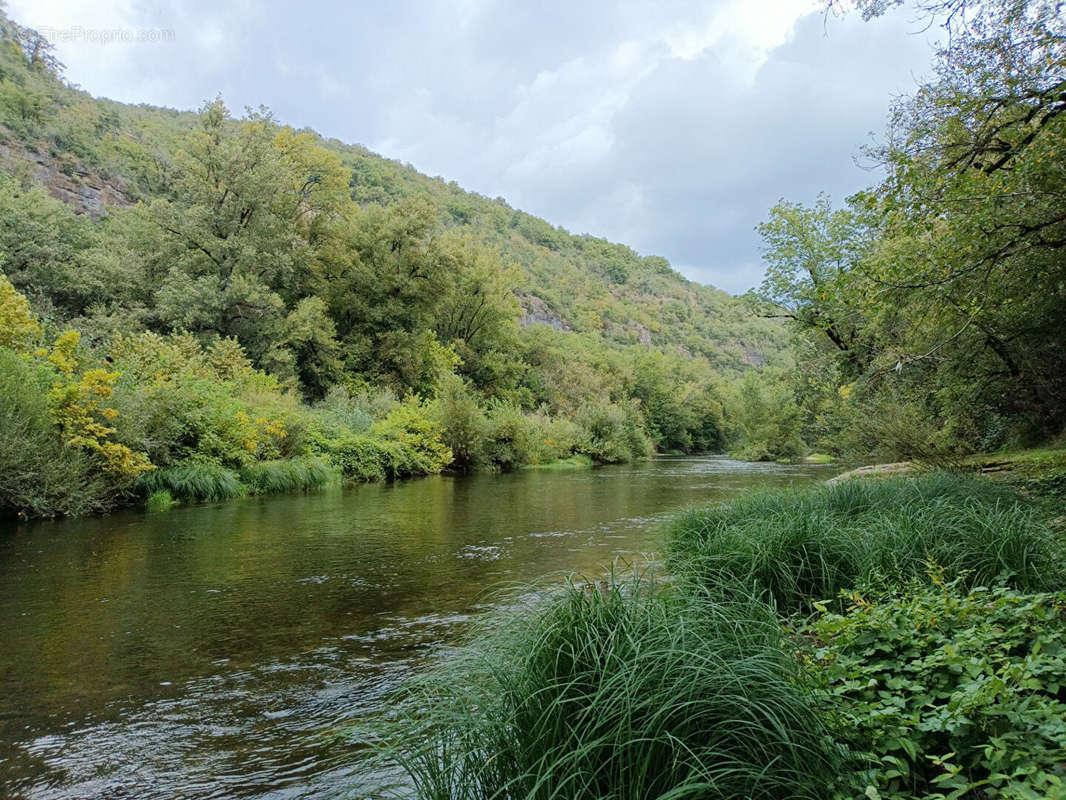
[753,0,1066,454]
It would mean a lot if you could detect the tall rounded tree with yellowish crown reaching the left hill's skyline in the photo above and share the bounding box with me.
[148,100,346,363]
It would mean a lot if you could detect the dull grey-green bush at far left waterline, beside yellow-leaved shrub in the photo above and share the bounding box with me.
[0,348,117,517]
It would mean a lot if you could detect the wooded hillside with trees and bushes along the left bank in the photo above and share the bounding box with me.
[0,6,789,517]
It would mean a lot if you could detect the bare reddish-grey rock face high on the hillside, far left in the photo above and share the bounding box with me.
[0,144,130,217]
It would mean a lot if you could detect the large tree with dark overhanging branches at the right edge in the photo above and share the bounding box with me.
[858,0,1066,435]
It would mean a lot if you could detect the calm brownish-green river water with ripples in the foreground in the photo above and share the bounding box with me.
[0,457,836,800]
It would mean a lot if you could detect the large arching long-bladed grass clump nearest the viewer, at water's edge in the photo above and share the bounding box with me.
[375,578,837,800]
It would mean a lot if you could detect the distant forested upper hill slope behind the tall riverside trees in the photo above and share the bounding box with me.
[0,13,784,372]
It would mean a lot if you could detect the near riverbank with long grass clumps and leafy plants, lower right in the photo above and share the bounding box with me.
[373,475,1066,800]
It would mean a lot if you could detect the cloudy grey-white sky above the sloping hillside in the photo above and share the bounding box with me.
[7,0,931,292]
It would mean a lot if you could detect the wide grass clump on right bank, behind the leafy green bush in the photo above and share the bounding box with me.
[667,474,1063,613]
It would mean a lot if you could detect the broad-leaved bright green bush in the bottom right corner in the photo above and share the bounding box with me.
[803,572,1066,800]
